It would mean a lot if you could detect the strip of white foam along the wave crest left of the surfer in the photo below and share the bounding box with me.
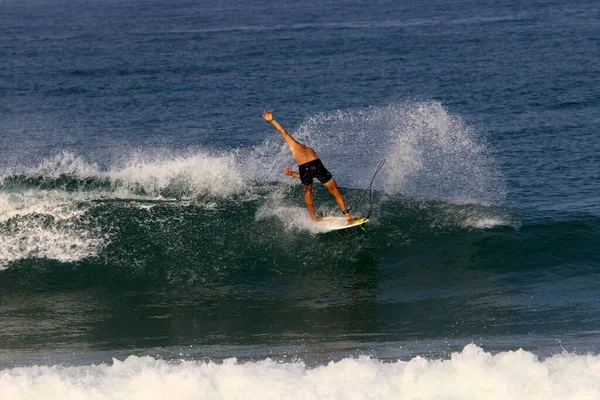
[0,151,247,199]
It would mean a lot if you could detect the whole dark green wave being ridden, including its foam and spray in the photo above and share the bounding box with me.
[0,101,600,329]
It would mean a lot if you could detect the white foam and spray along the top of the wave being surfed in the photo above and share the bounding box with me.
[0,101,510,267]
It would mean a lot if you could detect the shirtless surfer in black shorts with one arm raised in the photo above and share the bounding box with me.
[263,111,357,222]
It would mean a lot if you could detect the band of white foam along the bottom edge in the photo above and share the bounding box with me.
[0,345,600,400]
